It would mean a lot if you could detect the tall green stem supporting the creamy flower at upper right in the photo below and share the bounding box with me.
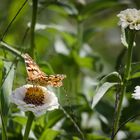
[112,30,135,140]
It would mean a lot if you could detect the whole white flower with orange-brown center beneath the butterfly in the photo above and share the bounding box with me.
[11,84,59,116]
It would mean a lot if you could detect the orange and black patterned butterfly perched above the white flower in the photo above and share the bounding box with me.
[23,53,66,87]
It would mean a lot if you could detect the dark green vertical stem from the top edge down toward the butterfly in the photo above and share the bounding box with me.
[29,0,38,57]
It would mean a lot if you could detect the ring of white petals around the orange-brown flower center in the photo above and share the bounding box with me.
[11,85,59,116]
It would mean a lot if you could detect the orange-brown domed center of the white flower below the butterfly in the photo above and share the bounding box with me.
[24,86,44,106]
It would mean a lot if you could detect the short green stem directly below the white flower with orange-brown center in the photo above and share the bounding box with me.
[23,112,34,140]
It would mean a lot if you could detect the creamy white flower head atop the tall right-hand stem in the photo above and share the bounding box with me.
[117,9,140,30]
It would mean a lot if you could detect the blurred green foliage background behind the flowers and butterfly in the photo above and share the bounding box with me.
[0,0,140,140]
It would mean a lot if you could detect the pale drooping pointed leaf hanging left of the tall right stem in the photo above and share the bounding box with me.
[92,82,118,109]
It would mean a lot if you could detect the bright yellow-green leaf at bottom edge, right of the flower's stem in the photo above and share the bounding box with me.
[39,129,60,140]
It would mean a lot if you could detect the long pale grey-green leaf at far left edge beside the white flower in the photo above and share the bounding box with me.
[0,61,15,139]
